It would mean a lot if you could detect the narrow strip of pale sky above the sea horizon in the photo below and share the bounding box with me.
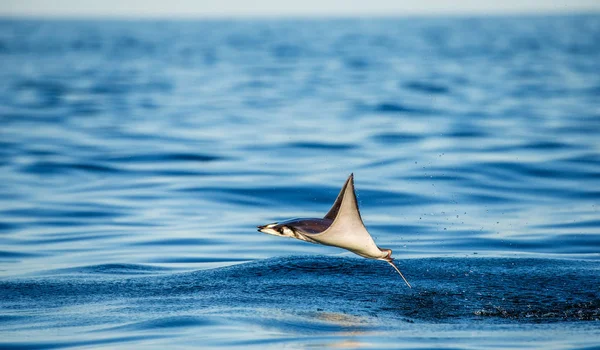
[0,0,600,18]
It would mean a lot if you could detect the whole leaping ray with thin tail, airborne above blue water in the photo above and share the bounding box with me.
[258,174,412,288]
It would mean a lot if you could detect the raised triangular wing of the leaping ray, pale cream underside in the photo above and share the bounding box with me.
[310,174,386,259]
